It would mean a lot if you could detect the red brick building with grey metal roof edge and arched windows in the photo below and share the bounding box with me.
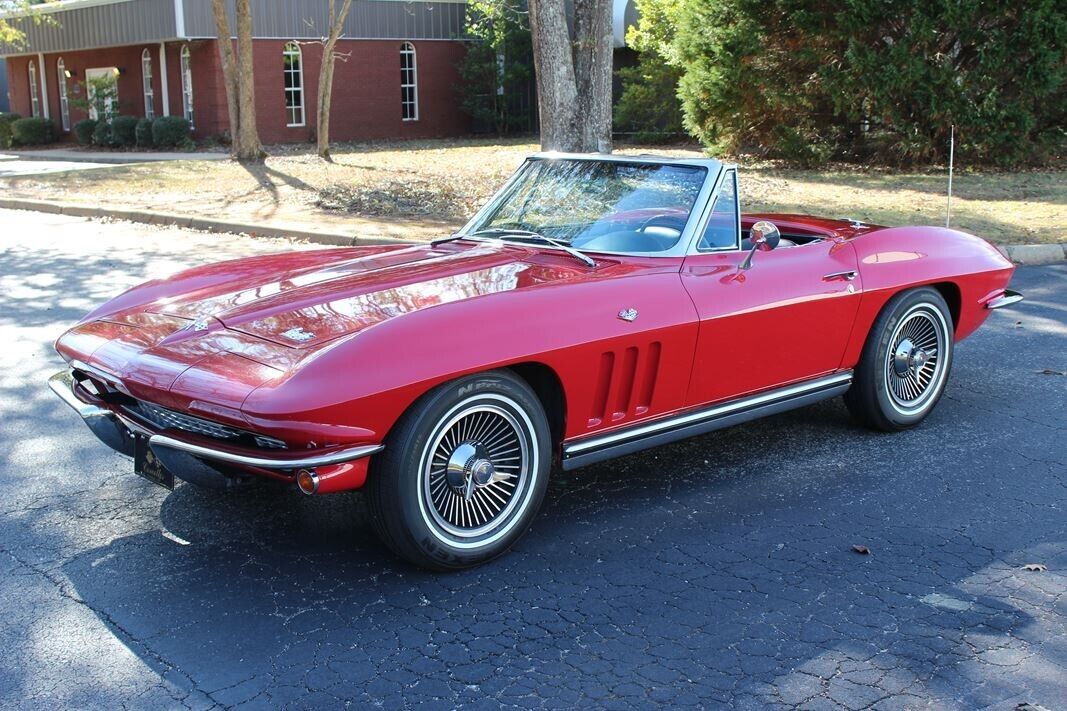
[0,0,471,143]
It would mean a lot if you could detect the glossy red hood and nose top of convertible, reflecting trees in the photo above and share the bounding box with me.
[57,243,589,414]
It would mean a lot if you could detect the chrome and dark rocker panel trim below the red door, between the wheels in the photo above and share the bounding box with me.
[562,370,853,471]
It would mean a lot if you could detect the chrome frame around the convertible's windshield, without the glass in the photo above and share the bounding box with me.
[456,153,723,257]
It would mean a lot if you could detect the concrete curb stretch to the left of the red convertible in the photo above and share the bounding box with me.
[0,198,411,247]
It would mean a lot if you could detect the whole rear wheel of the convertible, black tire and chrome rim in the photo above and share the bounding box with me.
[845,286,955,431]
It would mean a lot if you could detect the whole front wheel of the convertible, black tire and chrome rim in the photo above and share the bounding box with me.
[367,370,552,570]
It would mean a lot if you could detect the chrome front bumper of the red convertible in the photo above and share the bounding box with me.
[48,370,385,469]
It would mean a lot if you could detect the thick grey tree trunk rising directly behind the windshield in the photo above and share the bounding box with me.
[529,0,612,153]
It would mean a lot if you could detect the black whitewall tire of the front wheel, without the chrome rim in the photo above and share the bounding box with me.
[373,370,552,570]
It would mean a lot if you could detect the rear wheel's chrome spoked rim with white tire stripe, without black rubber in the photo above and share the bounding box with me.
[885,304,949,414]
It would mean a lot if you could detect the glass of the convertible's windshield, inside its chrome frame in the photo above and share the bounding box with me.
[465,159,706,253]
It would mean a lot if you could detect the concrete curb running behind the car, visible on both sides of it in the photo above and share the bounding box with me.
[0,198,1067,260]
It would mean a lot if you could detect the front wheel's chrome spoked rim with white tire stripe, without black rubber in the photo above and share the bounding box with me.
[420,395,537,546]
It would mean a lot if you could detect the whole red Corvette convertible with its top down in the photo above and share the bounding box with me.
[50,154,1022,569]
